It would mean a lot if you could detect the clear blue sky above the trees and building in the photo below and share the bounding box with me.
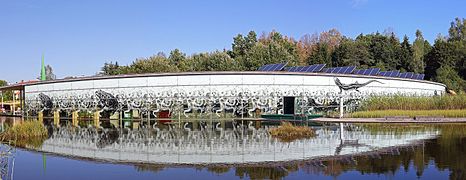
[0,0,466,82]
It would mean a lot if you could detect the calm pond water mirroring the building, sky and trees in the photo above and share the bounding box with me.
[0,117,466,179]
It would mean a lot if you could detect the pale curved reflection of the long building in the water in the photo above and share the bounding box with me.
[35,128,439,164]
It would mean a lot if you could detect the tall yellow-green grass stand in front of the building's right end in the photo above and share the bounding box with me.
[360,93,466,111]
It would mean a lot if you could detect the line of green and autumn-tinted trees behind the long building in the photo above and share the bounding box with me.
[100,18,466,91]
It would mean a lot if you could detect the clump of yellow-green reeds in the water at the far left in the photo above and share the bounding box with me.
[0,121,47,142]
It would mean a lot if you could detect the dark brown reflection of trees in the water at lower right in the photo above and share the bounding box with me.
[300,124,466,179]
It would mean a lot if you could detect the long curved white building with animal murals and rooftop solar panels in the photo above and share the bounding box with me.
[0,64,446,118]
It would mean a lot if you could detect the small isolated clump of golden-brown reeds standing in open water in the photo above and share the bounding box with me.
[269,122,315,142]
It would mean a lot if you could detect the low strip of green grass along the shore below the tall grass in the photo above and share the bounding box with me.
[349,109,466,118]
